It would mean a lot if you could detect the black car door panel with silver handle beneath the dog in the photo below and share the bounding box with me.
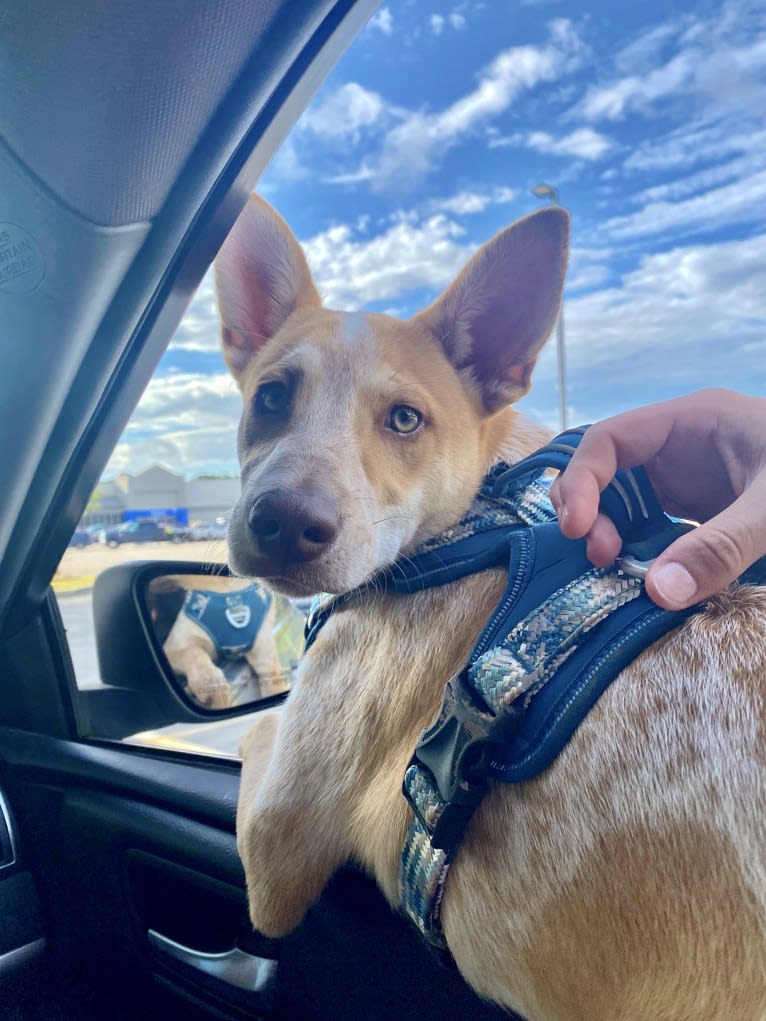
[0,728,516,1021]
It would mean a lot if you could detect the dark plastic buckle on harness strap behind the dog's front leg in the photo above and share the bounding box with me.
[402,674,527,850]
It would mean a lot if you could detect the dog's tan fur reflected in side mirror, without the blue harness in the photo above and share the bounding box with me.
[149,575,285,709]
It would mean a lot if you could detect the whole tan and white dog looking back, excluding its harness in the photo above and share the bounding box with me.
[216,197,766,1021]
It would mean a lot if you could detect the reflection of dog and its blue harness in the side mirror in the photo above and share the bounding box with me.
[149,575,284,709]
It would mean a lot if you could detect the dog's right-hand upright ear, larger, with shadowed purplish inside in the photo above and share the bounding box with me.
[416,206,569,411]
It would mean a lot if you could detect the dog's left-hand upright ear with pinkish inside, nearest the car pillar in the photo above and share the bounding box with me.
[216,195,321,381]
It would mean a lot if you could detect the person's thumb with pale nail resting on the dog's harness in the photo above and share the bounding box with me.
[647,478,766,610]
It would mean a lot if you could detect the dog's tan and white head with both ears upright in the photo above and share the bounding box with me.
[216,196,569,595]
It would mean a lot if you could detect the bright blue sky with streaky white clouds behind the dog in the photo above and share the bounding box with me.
[106,0,766,477]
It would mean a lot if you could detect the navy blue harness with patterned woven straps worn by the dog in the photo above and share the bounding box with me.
[306,428,763,950]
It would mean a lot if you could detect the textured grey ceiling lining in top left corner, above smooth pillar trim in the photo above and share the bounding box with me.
[0,0,290,226]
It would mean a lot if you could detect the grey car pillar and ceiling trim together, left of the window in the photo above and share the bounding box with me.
[0,0,378,633]
